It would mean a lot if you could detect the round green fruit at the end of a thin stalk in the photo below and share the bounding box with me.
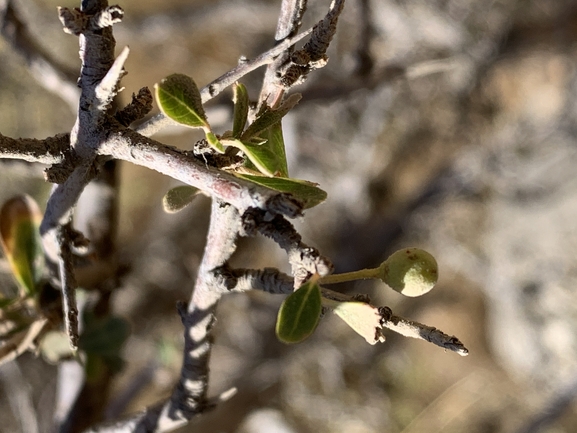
[379,248,439,297]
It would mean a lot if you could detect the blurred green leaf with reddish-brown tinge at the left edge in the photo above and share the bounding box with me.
[0,195,44,295]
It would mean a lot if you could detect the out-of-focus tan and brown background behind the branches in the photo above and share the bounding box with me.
[0,0,577,433]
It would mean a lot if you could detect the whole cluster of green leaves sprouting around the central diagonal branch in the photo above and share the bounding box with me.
[155,74,326,213]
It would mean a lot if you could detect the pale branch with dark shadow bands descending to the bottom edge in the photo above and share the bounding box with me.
[84,200,241,433]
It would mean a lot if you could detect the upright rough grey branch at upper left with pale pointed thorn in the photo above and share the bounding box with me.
[40,0,128,262]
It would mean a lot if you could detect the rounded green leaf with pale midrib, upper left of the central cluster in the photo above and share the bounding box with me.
[154,74,210,131]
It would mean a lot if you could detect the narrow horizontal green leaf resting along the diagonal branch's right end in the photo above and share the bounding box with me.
[234,173,327,209]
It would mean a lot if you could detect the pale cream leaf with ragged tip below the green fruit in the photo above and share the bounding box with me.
[323,298,385,344]
